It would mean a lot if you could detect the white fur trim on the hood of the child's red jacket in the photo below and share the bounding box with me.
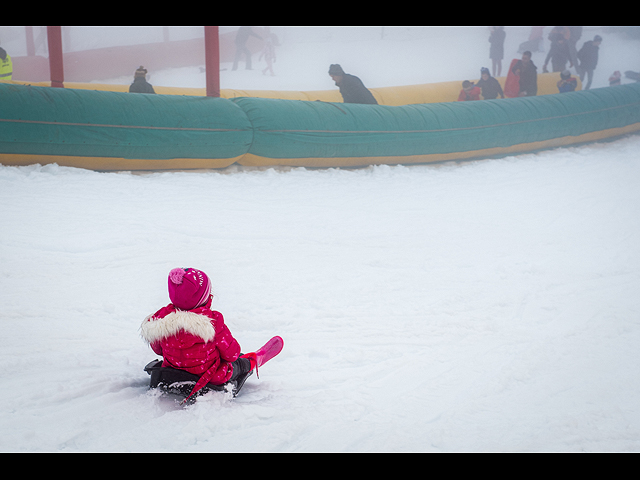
[140,310,216,343]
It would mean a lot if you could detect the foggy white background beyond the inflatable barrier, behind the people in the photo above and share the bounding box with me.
[0,26,640,90]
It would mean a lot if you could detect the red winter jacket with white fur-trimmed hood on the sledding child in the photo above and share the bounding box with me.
[140,297,240,393]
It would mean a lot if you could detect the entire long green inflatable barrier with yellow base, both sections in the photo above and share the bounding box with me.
[0,84,640,170]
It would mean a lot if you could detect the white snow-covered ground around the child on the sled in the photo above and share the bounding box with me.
[0,29,640,452]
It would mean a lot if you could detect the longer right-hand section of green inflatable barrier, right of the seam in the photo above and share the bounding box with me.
[233,84,640,166]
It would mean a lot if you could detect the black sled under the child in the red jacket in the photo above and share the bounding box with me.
[144,360,253,403]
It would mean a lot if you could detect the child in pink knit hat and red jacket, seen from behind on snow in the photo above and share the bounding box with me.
[140,268,282,399]
